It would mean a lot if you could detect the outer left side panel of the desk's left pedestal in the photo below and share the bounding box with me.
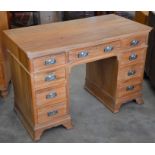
[9,53,35,134]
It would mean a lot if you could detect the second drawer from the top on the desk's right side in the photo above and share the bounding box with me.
[120,48,146,65]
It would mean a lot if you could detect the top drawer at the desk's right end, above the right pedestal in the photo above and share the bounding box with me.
[122,34,147,48]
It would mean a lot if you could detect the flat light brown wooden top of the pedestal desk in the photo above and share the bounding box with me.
[4,14,151,58]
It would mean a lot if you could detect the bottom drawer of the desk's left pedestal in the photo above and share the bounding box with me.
[38,103,67,123]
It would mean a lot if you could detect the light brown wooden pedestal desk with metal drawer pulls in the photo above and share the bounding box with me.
[3,15,151,140]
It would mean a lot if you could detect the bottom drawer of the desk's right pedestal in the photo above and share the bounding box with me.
[117,78,142,97]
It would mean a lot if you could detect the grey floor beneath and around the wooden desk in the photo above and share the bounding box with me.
[0,65,155,143]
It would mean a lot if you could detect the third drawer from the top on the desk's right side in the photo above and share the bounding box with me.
[118,63,144,81]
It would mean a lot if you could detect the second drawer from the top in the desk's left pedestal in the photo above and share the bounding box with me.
[34,68,66,89]
